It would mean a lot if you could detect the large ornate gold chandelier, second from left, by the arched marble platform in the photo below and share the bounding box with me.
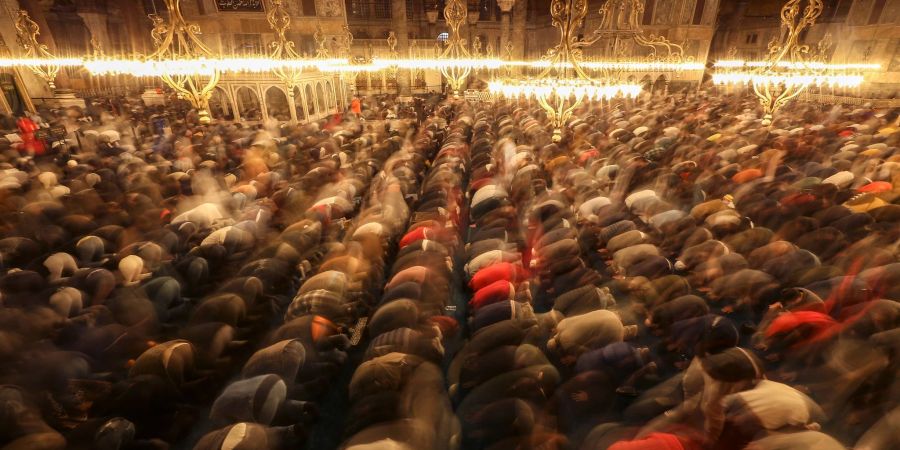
[146,0,221,124]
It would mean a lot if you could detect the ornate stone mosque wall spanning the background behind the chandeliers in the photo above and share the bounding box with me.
[0,0,888,110]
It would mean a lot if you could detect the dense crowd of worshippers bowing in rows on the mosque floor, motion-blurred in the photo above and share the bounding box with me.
[0,92,900,450]
